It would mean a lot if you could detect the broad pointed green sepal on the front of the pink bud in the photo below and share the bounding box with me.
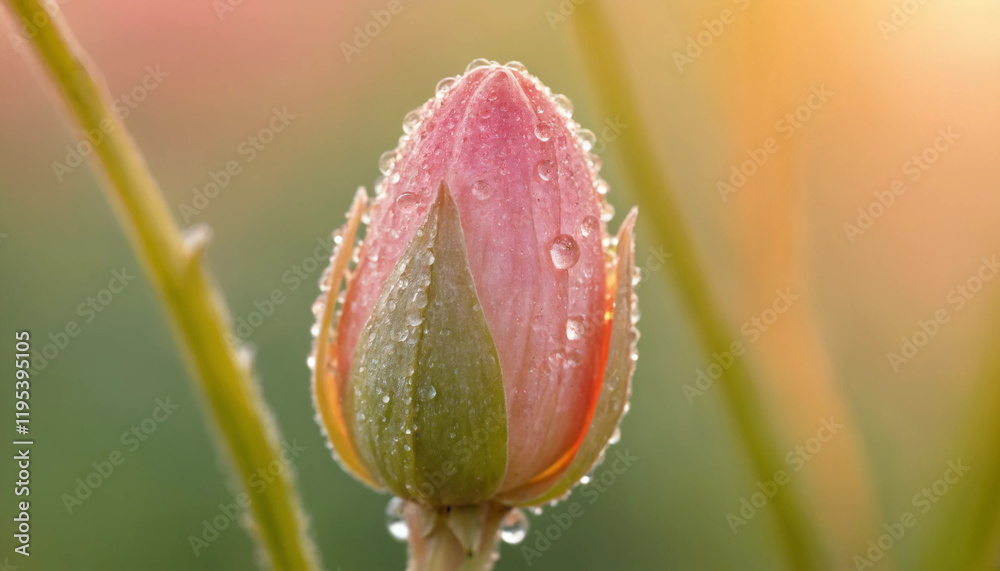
[348,183,507,506]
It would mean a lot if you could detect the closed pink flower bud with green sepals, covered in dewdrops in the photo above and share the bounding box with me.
[310,60,638,506]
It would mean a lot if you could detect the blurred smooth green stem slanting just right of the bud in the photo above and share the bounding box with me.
[570,0,829,569]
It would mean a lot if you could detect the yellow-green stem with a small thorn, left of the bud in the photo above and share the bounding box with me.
[7,0,318,570]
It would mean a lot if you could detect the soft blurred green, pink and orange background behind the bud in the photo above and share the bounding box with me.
[0,0,1000,571]
